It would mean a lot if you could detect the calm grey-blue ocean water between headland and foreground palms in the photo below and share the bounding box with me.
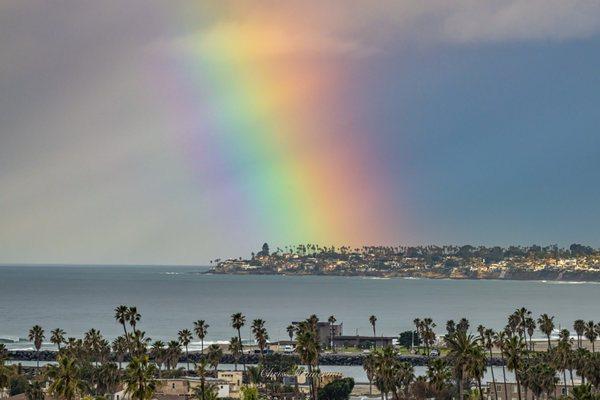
[0,266,600,349]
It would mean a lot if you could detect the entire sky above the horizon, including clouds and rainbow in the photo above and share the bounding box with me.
[0,0,600,265]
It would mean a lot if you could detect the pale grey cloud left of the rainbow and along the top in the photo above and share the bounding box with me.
[0,0,600,263]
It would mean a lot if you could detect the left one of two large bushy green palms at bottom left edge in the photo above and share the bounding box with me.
[47,355,84,400]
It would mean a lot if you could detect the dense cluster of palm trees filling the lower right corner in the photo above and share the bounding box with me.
[363,307,600,400]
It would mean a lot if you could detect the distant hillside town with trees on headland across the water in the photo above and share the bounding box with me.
[209,243,600,281]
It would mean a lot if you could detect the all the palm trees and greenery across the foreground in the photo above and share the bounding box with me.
[0,306,600,400]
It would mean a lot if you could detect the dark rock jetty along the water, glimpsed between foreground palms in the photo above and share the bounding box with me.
[8,350,502,366]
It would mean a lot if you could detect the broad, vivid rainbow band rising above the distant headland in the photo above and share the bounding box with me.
[148,12,390,245]
